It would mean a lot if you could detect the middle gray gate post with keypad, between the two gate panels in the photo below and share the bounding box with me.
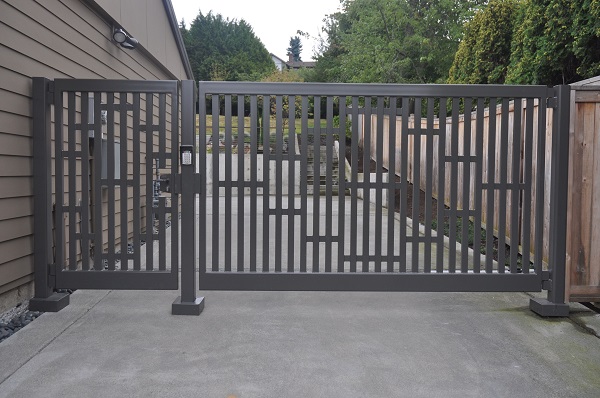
[171,80,204,315]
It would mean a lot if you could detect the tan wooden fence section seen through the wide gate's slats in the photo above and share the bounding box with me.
[361,100,552,263]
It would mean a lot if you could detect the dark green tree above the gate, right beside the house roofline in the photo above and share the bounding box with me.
[180,12,275,80]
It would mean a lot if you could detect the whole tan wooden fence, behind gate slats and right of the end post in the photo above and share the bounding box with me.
[359,84,600,301]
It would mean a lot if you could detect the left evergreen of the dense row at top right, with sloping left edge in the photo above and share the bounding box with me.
[448,0,522,84]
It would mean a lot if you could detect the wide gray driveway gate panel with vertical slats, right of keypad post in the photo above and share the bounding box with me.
[198,82,554,291]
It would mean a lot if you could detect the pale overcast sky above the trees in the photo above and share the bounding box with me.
[171,0,340,61]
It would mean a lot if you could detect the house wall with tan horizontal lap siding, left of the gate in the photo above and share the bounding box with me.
[0,0,193,311]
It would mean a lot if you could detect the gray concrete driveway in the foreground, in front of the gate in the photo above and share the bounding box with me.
[0,290,600,398]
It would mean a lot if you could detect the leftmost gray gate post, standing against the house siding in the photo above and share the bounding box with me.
[29,77,69,312]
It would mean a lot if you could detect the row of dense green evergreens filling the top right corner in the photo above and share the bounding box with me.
[449,0,600,85]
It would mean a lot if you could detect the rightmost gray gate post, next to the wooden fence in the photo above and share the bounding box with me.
[529,85,571,316]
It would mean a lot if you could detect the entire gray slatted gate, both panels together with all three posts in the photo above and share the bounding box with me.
[34,80,569,315]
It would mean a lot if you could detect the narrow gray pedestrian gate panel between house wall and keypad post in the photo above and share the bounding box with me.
[43,80,179,289]
